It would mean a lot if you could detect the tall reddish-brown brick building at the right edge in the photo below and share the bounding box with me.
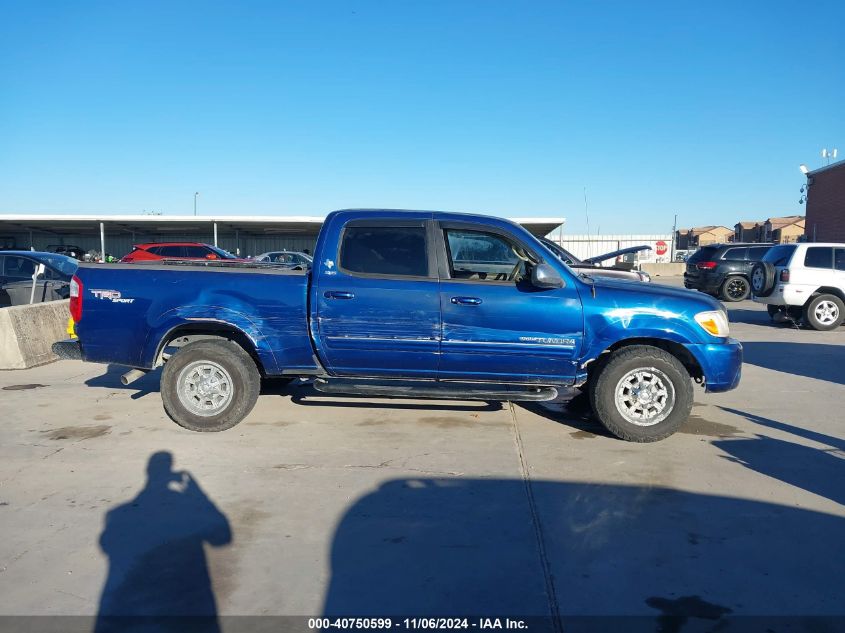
[805,160,845,242]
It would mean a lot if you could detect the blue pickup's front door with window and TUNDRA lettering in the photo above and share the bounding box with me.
[436,223,583,384]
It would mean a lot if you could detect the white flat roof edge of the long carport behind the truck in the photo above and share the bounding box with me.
[0,213,566,237]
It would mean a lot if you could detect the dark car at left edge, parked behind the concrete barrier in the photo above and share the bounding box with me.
[0,251,79,307]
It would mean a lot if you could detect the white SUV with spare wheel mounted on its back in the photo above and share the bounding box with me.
[751,242,845,330]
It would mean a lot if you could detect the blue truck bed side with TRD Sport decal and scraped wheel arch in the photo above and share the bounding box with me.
[76,260,314,375]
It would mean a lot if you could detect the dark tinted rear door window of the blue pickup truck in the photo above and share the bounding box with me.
[340,225,429,277]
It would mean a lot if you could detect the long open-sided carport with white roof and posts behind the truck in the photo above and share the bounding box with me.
[0,214,565,258]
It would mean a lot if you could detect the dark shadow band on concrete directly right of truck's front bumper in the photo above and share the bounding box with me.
[742,341,845,385]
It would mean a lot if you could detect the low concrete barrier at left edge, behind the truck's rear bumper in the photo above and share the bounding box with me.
[0,299,70,369]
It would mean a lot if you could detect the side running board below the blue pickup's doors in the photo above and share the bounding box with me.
[314,378,558,402]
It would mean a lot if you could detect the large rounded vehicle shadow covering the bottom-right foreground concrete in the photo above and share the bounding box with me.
[324,474,845,631]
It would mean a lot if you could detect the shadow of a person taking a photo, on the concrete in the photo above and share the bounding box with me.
[94,451,232,633]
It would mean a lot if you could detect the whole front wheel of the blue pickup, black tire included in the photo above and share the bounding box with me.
[589,345,693,442]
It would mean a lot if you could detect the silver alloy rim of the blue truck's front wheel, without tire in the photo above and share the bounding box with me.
[614,367,675,426]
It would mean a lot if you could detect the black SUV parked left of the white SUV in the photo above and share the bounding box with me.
[684,244,772,301]
